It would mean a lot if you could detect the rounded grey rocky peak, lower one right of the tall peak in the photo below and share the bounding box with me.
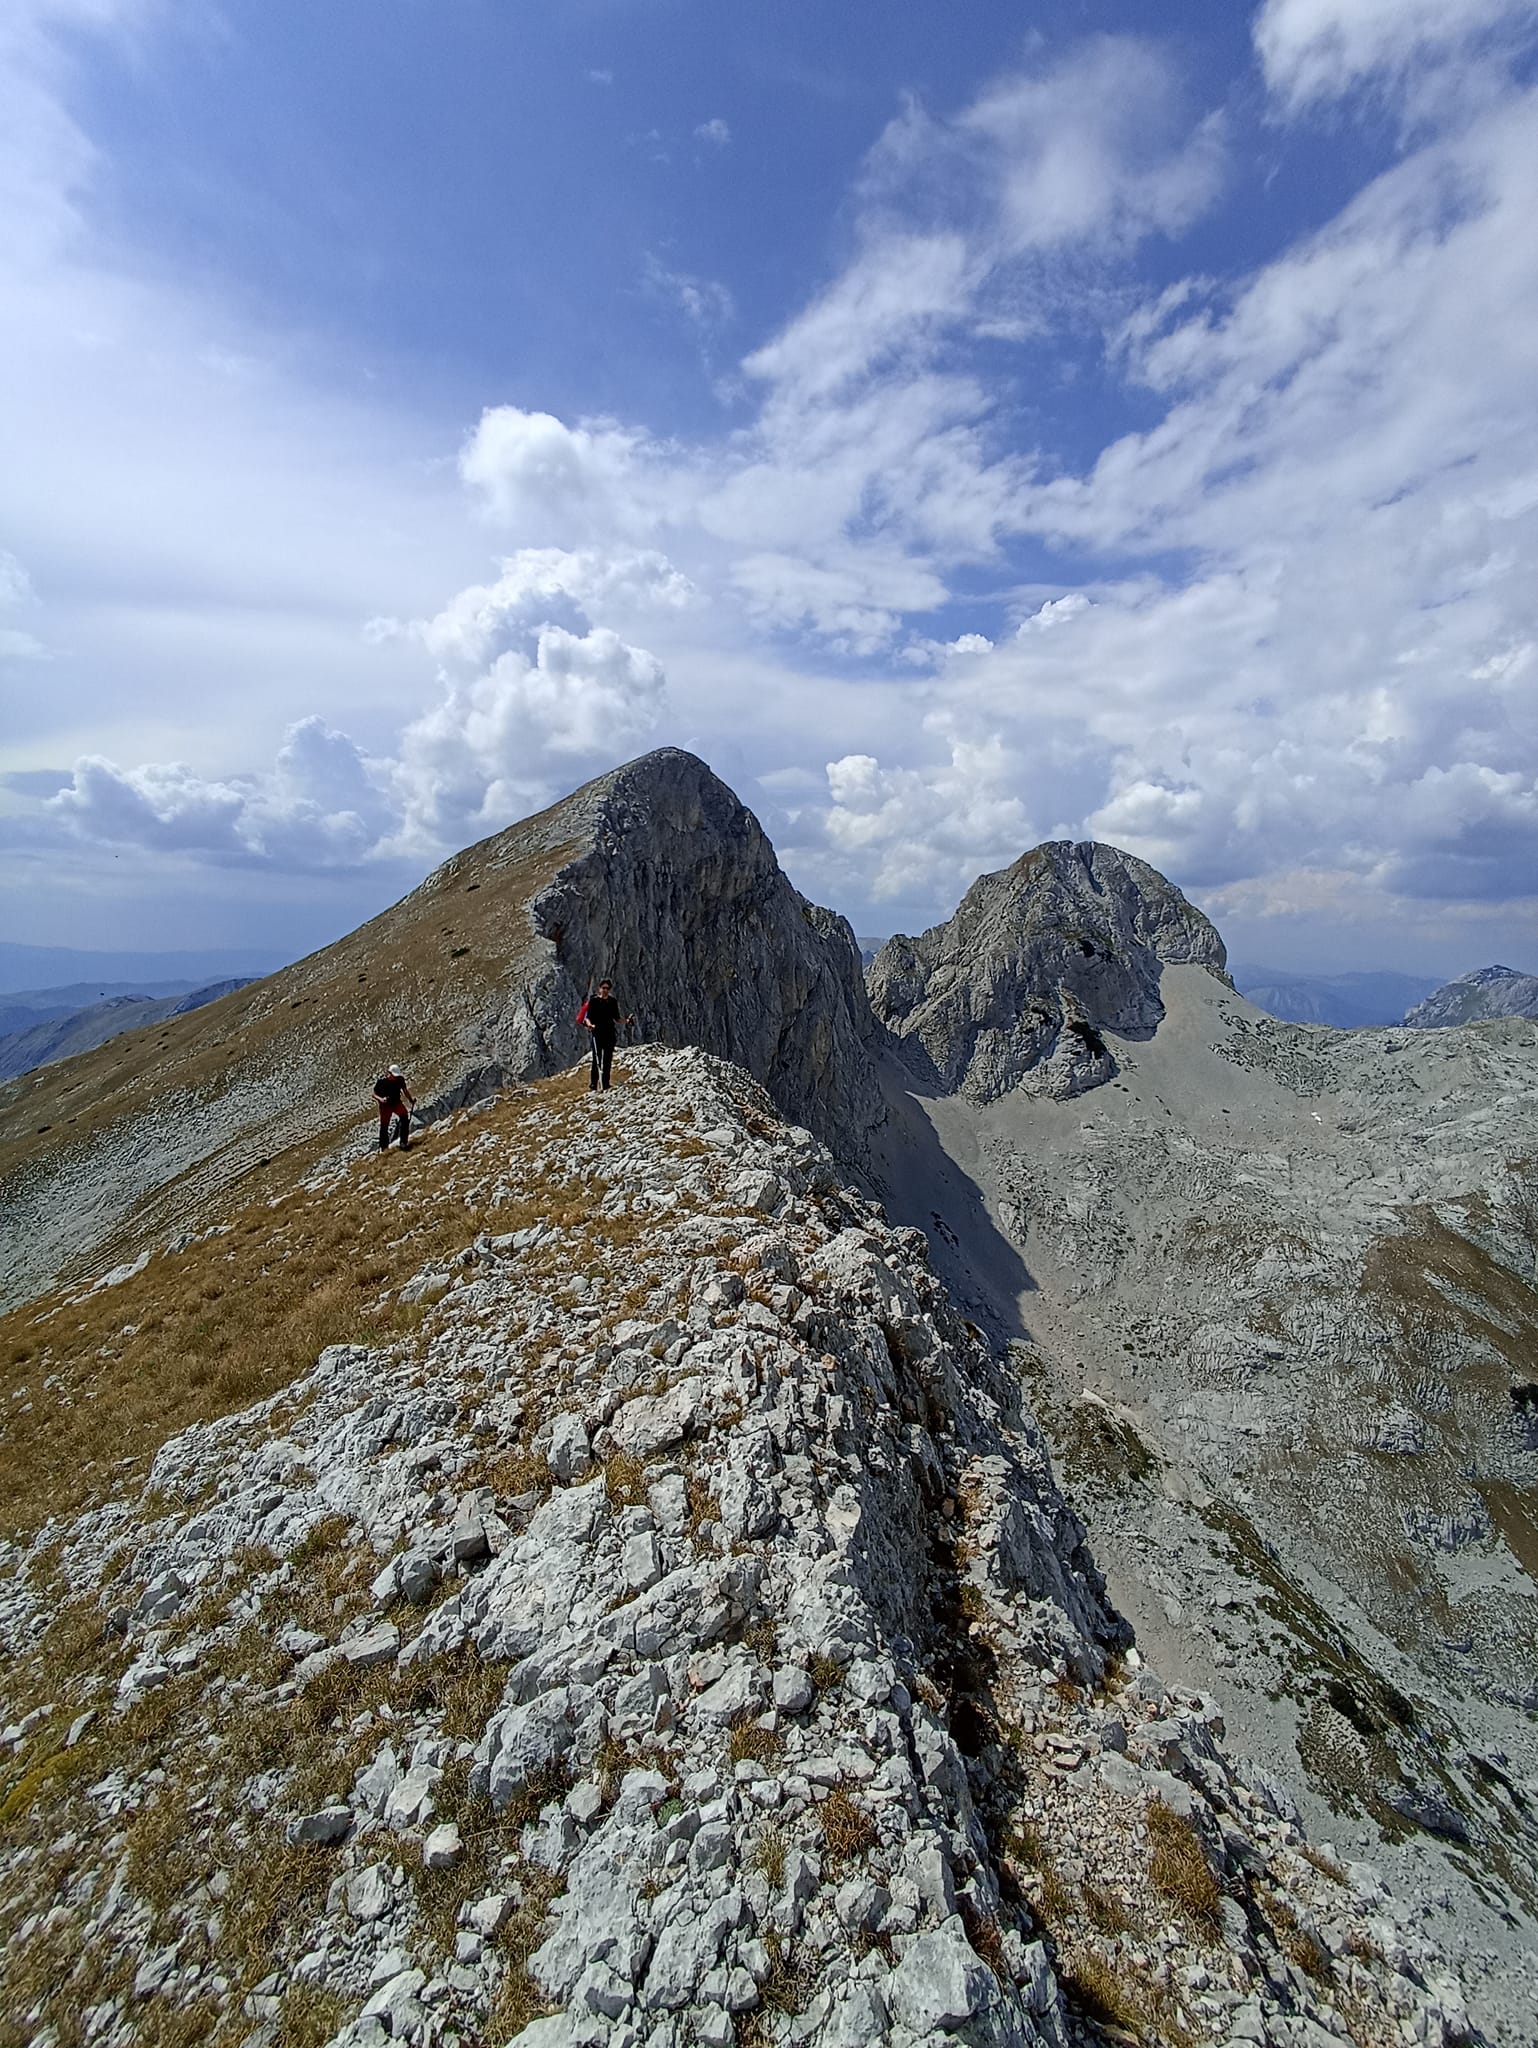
[866,840,1227,1102]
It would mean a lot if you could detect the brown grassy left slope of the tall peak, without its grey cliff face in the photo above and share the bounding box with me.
[0,815,582,1298]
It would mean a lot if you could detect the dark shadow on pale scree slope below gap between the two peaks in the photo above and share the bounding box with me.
[868,1055,1036,1343]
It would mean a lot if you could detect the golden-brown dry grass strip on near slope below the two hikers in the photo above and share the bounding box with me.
[0,1073,606,1538]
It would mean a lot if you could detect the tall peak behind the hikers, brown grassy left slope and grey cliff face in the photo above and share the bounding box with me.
[0,748,883,1300]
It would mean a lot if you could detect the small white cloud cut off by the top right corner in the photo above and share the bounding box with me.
[1255,0,1534,106]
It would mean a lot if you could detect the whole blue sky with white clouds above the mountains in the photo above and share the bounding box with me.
[0,0,1538,975]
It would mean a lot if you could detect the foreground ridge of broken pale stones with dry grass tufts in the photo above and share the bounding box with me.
[0,1051,1466,2048]
